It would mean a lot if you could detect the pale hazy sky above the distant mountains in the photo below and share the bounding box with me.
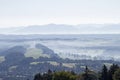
[0,0,120,27]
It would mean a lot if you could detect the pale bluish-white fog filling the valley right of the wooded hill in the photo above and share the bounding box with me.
[38,39,120,59]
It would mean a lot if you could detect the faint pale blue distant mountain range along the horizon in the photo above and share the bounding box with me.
[0,24,120,34]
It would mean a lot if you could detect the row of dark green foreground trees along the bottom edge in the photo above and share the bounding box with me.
[34,64,120,80]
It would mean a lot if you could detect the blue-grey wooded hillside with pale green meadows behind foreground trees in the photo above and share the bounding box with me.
[0,44,120,80]
